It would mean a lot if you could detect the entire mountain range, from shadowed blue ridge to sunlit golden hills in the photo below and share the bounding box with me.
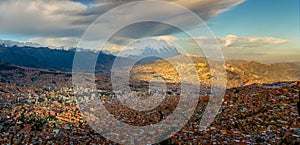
[0,40,300,88]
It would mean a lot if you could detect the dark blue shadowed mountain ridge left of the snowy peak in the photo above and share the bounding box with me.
[0,45,115,71]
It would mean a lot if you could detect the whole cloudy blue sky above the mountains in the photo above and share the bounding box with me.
[0,0,300,63]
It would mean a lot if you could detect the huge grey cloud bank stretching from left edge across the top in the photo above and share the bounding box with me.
[0,0,245,46]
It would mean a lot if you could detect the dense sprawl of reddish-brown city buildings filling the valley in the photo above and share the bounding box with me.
[0,83,300,144]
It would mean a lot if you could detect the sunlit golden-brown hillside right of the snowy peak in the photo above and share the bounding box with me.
[131,55,300,88]
